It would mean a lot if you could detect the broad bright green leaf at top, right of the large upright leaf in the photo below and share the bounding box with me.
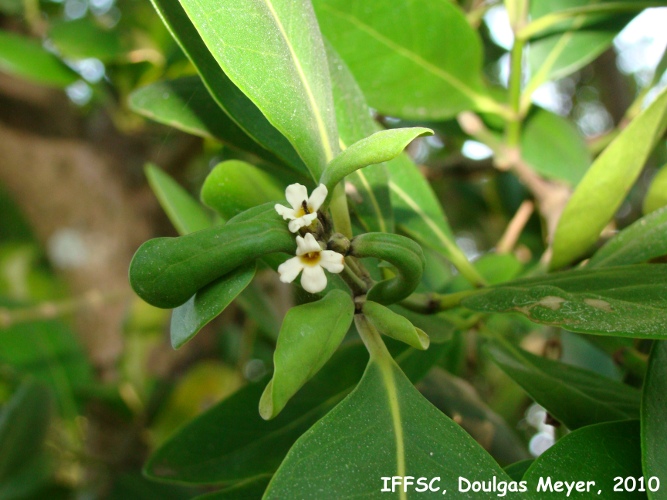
[313,0,498,119]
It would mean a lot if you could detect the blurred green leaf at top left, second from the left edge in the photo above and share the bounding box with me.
[49,17,127,62]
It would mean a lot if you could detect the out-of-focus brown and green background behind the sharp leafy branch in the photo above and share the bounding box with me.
[0,0,667,499]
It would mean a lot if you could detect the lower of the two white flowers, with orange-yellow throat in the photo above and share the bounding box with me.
[278,233,345,293]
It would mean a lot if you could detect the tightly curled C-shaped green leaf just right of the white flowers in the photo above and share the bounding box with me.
[350,233,426,305]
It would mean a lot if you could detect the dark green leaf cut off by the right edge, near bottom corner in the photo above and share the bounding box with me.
[641,341,667,499]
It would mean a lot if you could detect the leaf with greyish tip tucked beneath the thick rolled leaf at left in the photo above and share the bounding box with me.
[171,263,255,349]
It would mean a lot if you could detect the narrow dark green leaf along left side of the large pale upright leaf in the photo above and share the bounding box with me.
[152,0,308,174]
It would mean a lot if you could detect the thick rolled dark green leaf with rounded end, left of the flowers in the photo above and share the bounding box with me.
[130,214,296,309]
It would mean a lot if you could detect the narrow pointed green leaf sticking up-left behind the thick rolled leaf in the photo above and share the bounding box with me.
[144,163,212,234]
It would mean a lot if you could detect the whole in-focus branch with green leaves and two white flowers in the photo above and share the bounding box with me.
[120,0,667,498]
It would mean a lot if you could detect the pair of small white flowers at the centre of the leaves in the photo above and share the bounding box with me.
[275,184,345,293]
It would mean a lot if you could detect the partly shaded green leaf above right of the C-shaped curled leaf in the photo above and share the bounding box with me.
[387,155,484,284]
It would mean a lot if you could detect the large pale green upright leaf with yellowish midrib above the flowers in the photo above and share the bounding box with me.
[181,0,338,179]
